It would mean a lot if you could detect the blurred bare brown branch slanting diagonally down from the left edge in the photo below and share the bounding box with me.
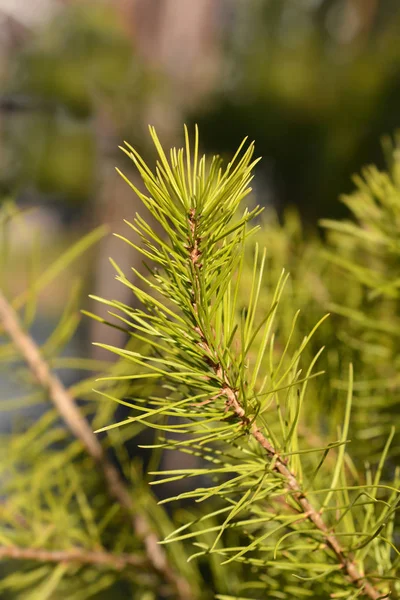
[0,290,192,600]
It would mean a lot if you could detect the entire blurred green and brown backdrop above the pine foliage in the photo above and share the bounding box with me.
[0,0,400,412]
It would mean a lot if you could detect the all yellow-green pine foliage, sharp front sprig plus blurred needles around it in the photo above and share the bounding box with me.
[0,129,400,600]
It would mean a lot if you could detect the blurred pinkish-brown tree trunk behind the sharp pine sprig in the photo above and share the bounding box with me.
[90,0,218,360]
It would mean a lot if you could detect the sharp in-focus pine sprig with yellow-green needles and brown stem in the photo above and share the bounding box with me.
[94,129,398,600]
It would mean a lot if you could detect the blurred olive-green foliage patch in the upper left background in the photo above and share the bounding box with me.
[2,3,142,204]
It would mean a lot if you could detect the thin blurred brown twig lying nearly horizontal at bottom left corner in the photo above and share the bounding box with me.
[0,546,149,571]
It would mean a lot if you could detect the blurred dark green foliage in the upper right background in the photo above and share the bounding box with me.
[195,0,400,221]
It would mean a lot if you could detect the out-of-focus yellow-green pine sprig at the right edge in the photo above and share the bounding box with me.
[322,136,400,456]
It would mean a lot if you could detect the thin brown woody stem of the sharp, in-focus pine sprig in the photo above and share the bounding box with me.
[188,209,382,600]
